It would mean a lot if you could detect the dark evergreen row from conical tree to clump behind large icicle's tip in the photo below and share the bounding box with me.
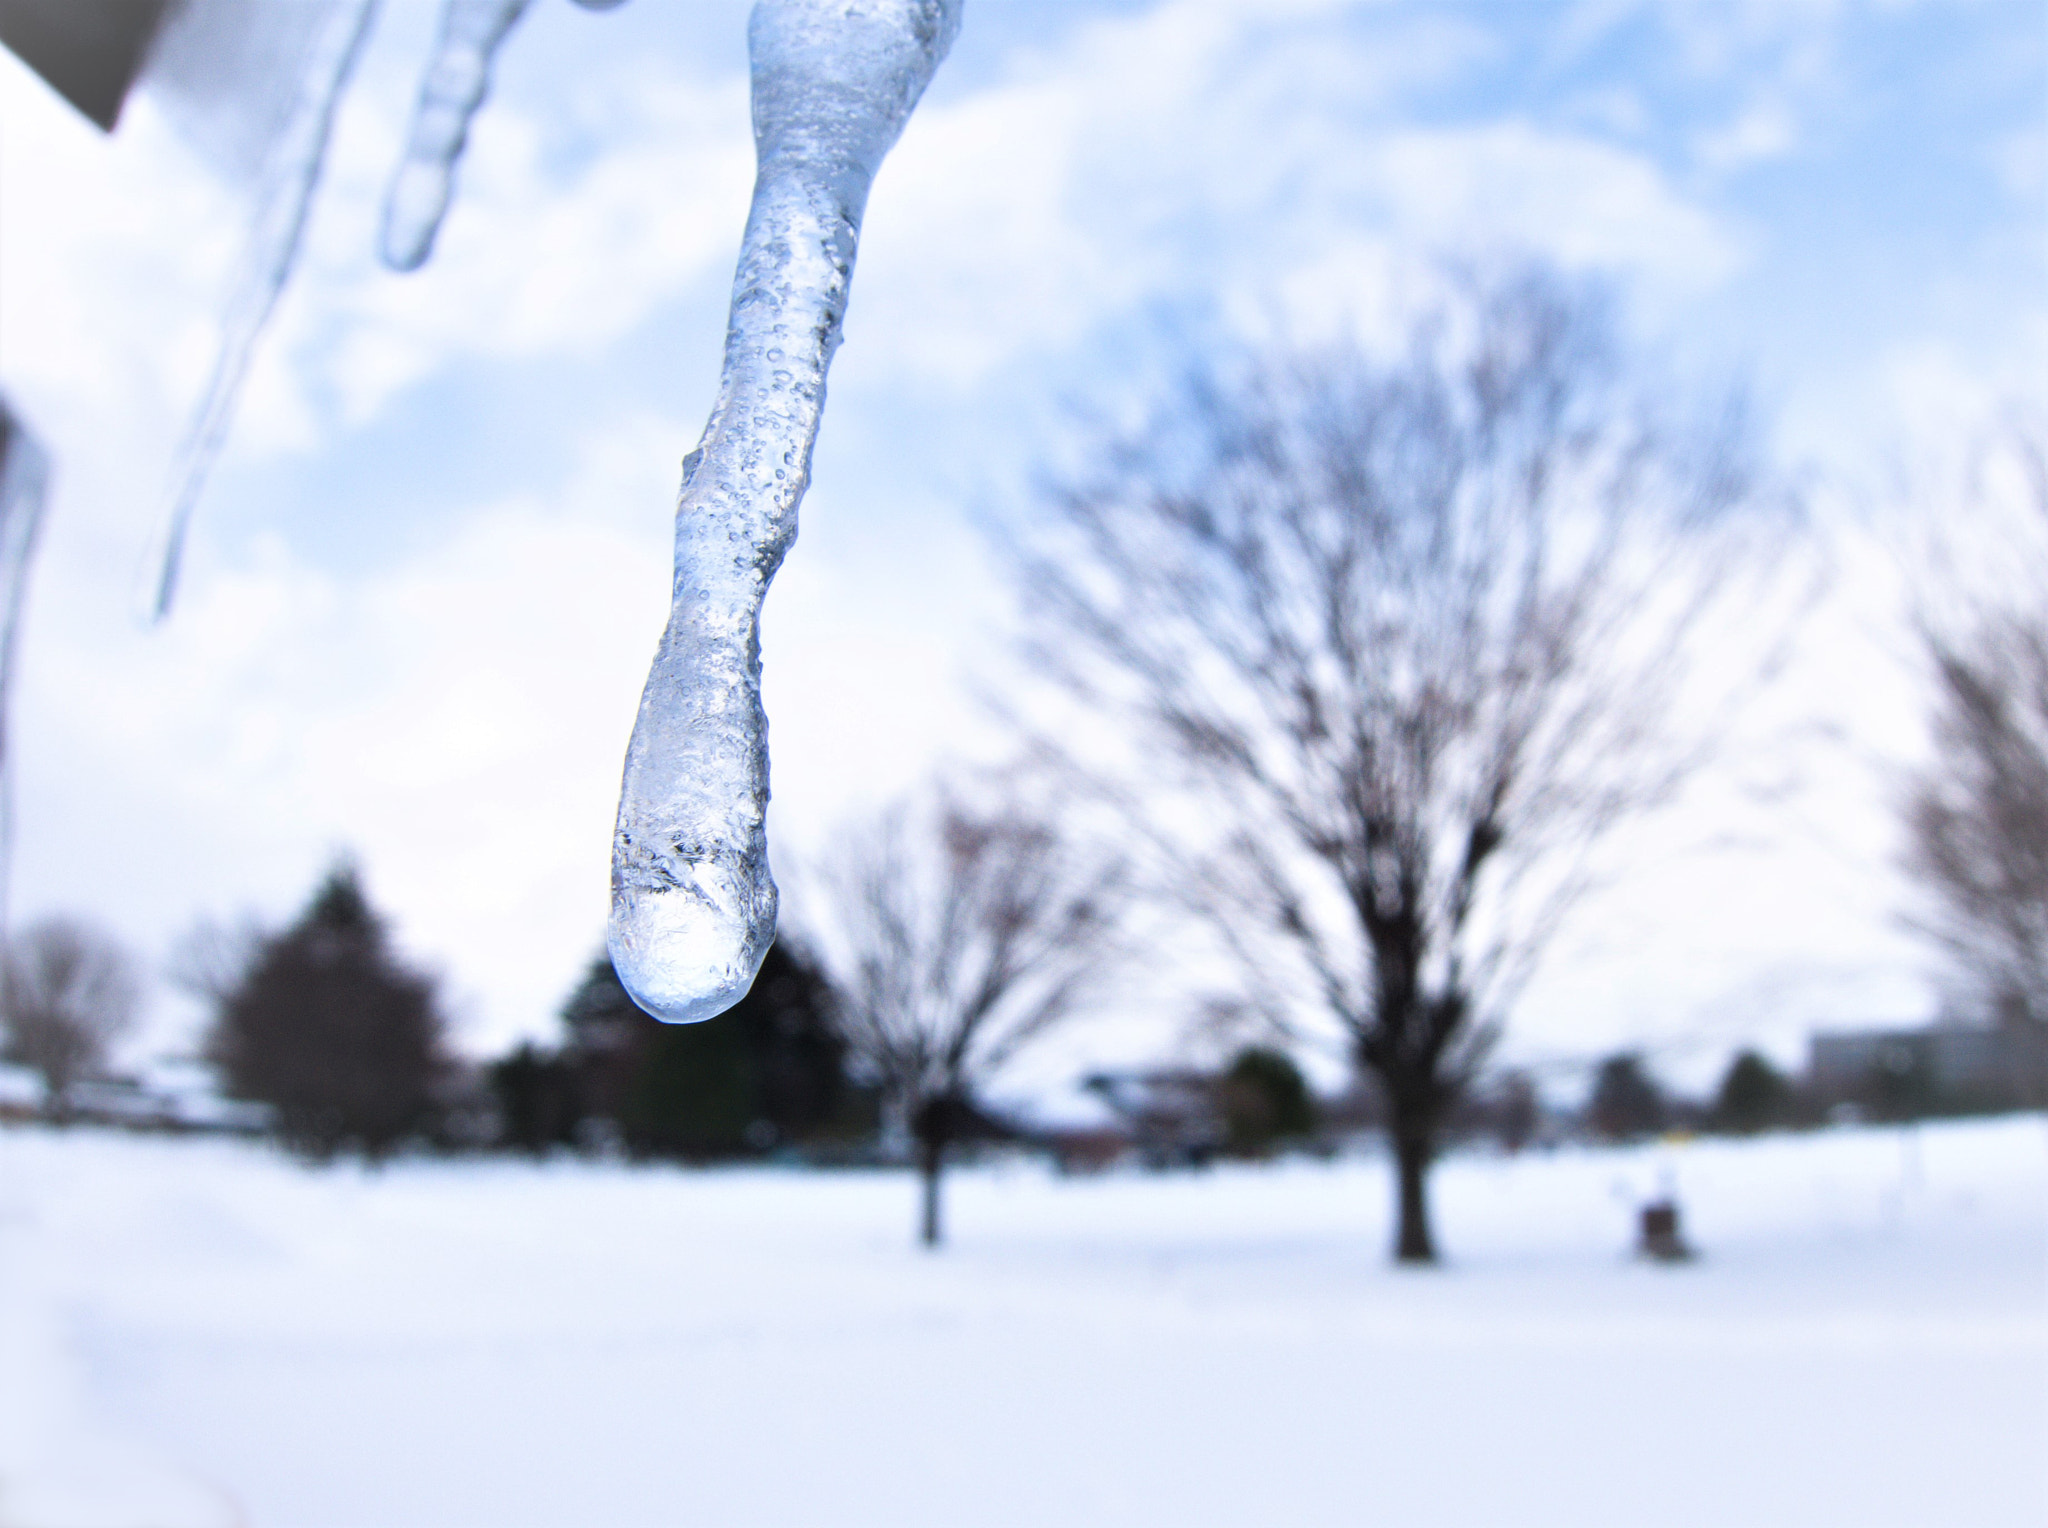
[180,864,879,1161]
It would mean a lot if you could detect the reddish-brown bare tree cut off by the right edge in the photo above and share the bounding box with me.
[1901,413,2048,1096]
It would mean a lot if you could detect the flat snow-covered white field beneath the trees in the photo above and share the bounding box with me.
[0,1116,2048,1528]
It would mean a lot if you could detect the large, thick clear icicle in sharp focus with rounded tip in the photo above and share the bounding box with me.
[606,0,961,1024]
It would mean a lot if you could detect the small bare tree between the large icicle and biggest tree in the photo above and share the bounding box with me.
[817,799,1124,1245]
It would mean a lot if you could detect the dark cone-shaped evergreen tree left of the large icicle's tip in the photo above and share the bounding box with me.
[207,864,446,1157]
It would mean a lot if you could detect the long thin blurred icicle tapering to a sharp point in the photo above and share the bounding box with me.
[152,0,377,621]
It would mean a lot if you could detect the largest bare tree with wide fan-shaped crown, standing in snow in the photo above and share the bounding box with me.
[1016,270,1785,1262]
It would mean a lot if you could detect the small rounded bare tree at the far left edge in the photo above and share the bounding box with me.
[0,918,141,1120]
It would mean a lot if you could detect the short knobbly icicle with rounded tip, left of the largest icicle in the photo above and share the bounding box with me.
[379,0,526,270]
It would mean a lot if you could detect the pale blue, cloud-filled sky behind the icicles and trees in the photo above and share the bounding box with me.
[0,0,2048,1077]
